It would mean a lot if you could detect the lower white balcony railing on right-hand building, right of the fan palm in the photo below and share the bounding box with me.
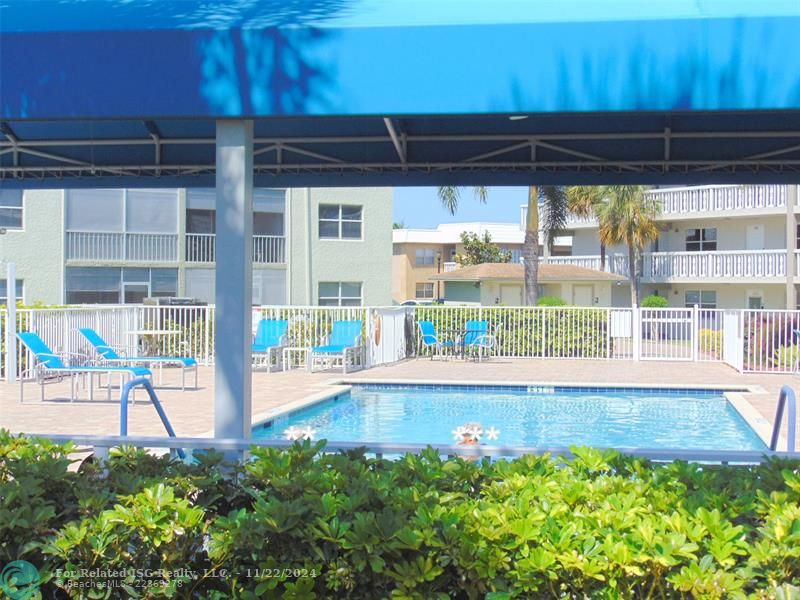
[642,250,786,281]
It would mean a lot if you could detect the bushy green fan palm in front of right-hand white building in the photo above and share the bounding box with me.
[593,185,660,307]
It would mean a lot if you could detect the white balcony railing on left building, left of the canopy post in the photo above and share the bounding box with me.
[67,231,178,262]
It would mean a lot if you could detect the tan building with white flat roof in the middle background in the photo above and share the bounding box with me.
[392,222,570,303]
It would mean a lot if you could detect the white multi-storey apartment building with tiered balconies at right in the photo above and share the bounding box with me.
[544,185,800,309]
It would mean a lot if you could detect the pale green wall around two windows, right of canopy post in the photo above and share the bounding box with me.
[287,188,393,306]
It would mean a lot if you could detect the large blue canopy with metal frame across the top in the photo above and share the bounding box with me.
[0,0,800,187]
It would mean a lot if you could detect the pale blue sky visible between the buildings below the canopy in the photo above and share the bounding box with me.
[394,187,528,228]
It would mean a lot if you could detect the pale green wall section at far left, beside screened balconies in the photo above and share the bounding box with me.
[0,190,64,304]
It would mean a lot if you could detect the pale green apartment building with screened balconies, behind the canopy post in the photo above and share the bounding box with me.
[0,188,392,306]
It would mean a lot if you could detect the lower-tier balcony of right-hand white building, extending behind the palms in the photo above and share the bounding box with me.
[548,250,788,282]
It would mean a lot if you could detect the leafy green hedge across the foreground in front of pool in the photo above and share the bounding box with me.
[0,432,800,599]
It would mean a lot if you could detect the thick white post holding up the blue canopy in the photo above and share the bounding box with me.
[214,120,253,438]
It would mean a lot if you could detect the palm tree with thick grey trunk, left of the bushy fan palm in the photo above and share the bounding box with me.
[522,185,569,306]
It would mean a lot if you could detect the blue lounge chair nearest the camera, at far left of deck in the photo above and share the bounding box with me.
[17,331,152,402]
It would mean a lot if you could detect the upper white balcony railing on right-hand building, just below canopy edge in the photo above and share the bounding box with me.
[564,185,787,226]
